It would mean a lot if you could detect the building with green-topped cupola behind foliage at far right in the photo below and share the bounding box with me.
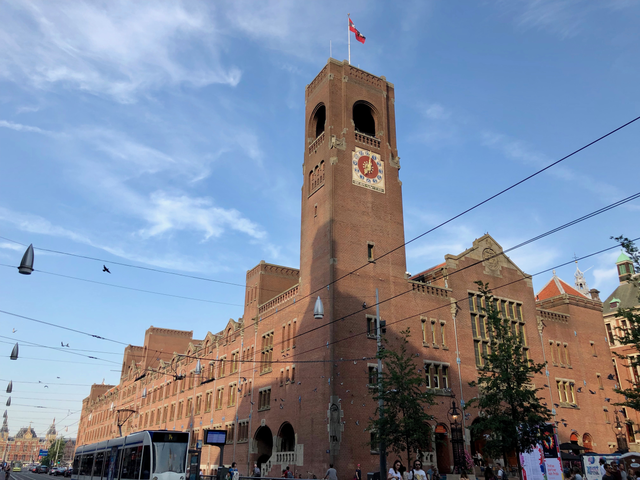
[602,253,640,452]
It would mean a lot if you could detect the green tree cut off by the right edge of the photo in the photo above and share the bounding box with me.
[614,236,640,411]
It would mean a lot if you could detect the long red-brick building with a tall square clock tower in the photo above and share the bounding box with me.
[78,59,615,478]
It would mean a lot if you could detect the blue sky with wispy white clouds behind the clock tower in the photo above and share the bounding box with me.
[0,0,640,436]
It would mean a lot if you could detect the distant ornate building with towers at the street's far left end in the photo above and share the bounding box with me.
[0,417,56,462]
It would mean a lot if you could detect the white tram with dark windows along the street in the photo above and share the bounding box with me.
[71,430,189,480]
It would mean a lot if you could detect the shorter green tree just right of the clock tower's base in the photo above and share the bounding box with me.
[367,328,435,465]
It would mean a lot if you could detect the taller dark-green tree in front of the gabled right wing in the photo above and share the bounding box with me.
[465,281,551,474]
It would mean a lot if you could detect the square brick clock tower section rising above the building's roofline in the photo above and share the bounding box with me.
[300,59,406,298]
